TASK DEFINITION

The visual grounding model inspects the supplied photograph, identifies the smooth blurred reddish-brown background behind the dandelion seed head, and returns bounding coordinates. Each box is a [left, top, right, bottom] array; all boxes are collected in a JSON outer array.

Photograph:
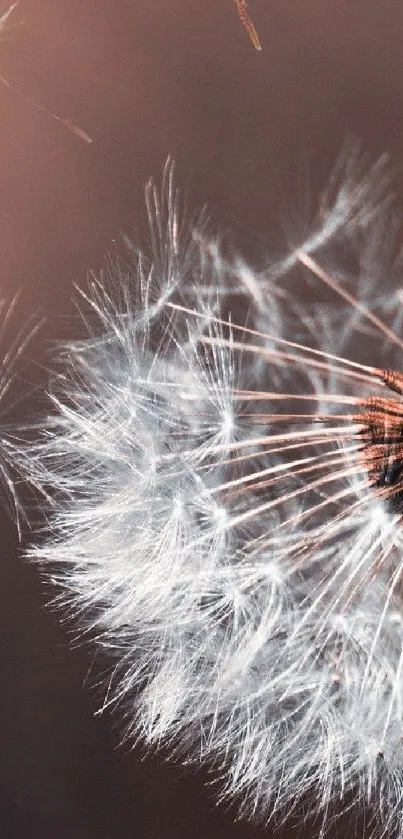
[[0, 0, 403, 839]]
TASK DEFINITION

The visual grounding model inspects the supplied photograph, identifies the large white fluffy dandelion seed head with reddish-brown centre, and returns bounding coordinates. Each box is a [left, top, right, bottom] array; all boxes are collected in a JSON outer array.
[[24, 158, 403, 836]]
